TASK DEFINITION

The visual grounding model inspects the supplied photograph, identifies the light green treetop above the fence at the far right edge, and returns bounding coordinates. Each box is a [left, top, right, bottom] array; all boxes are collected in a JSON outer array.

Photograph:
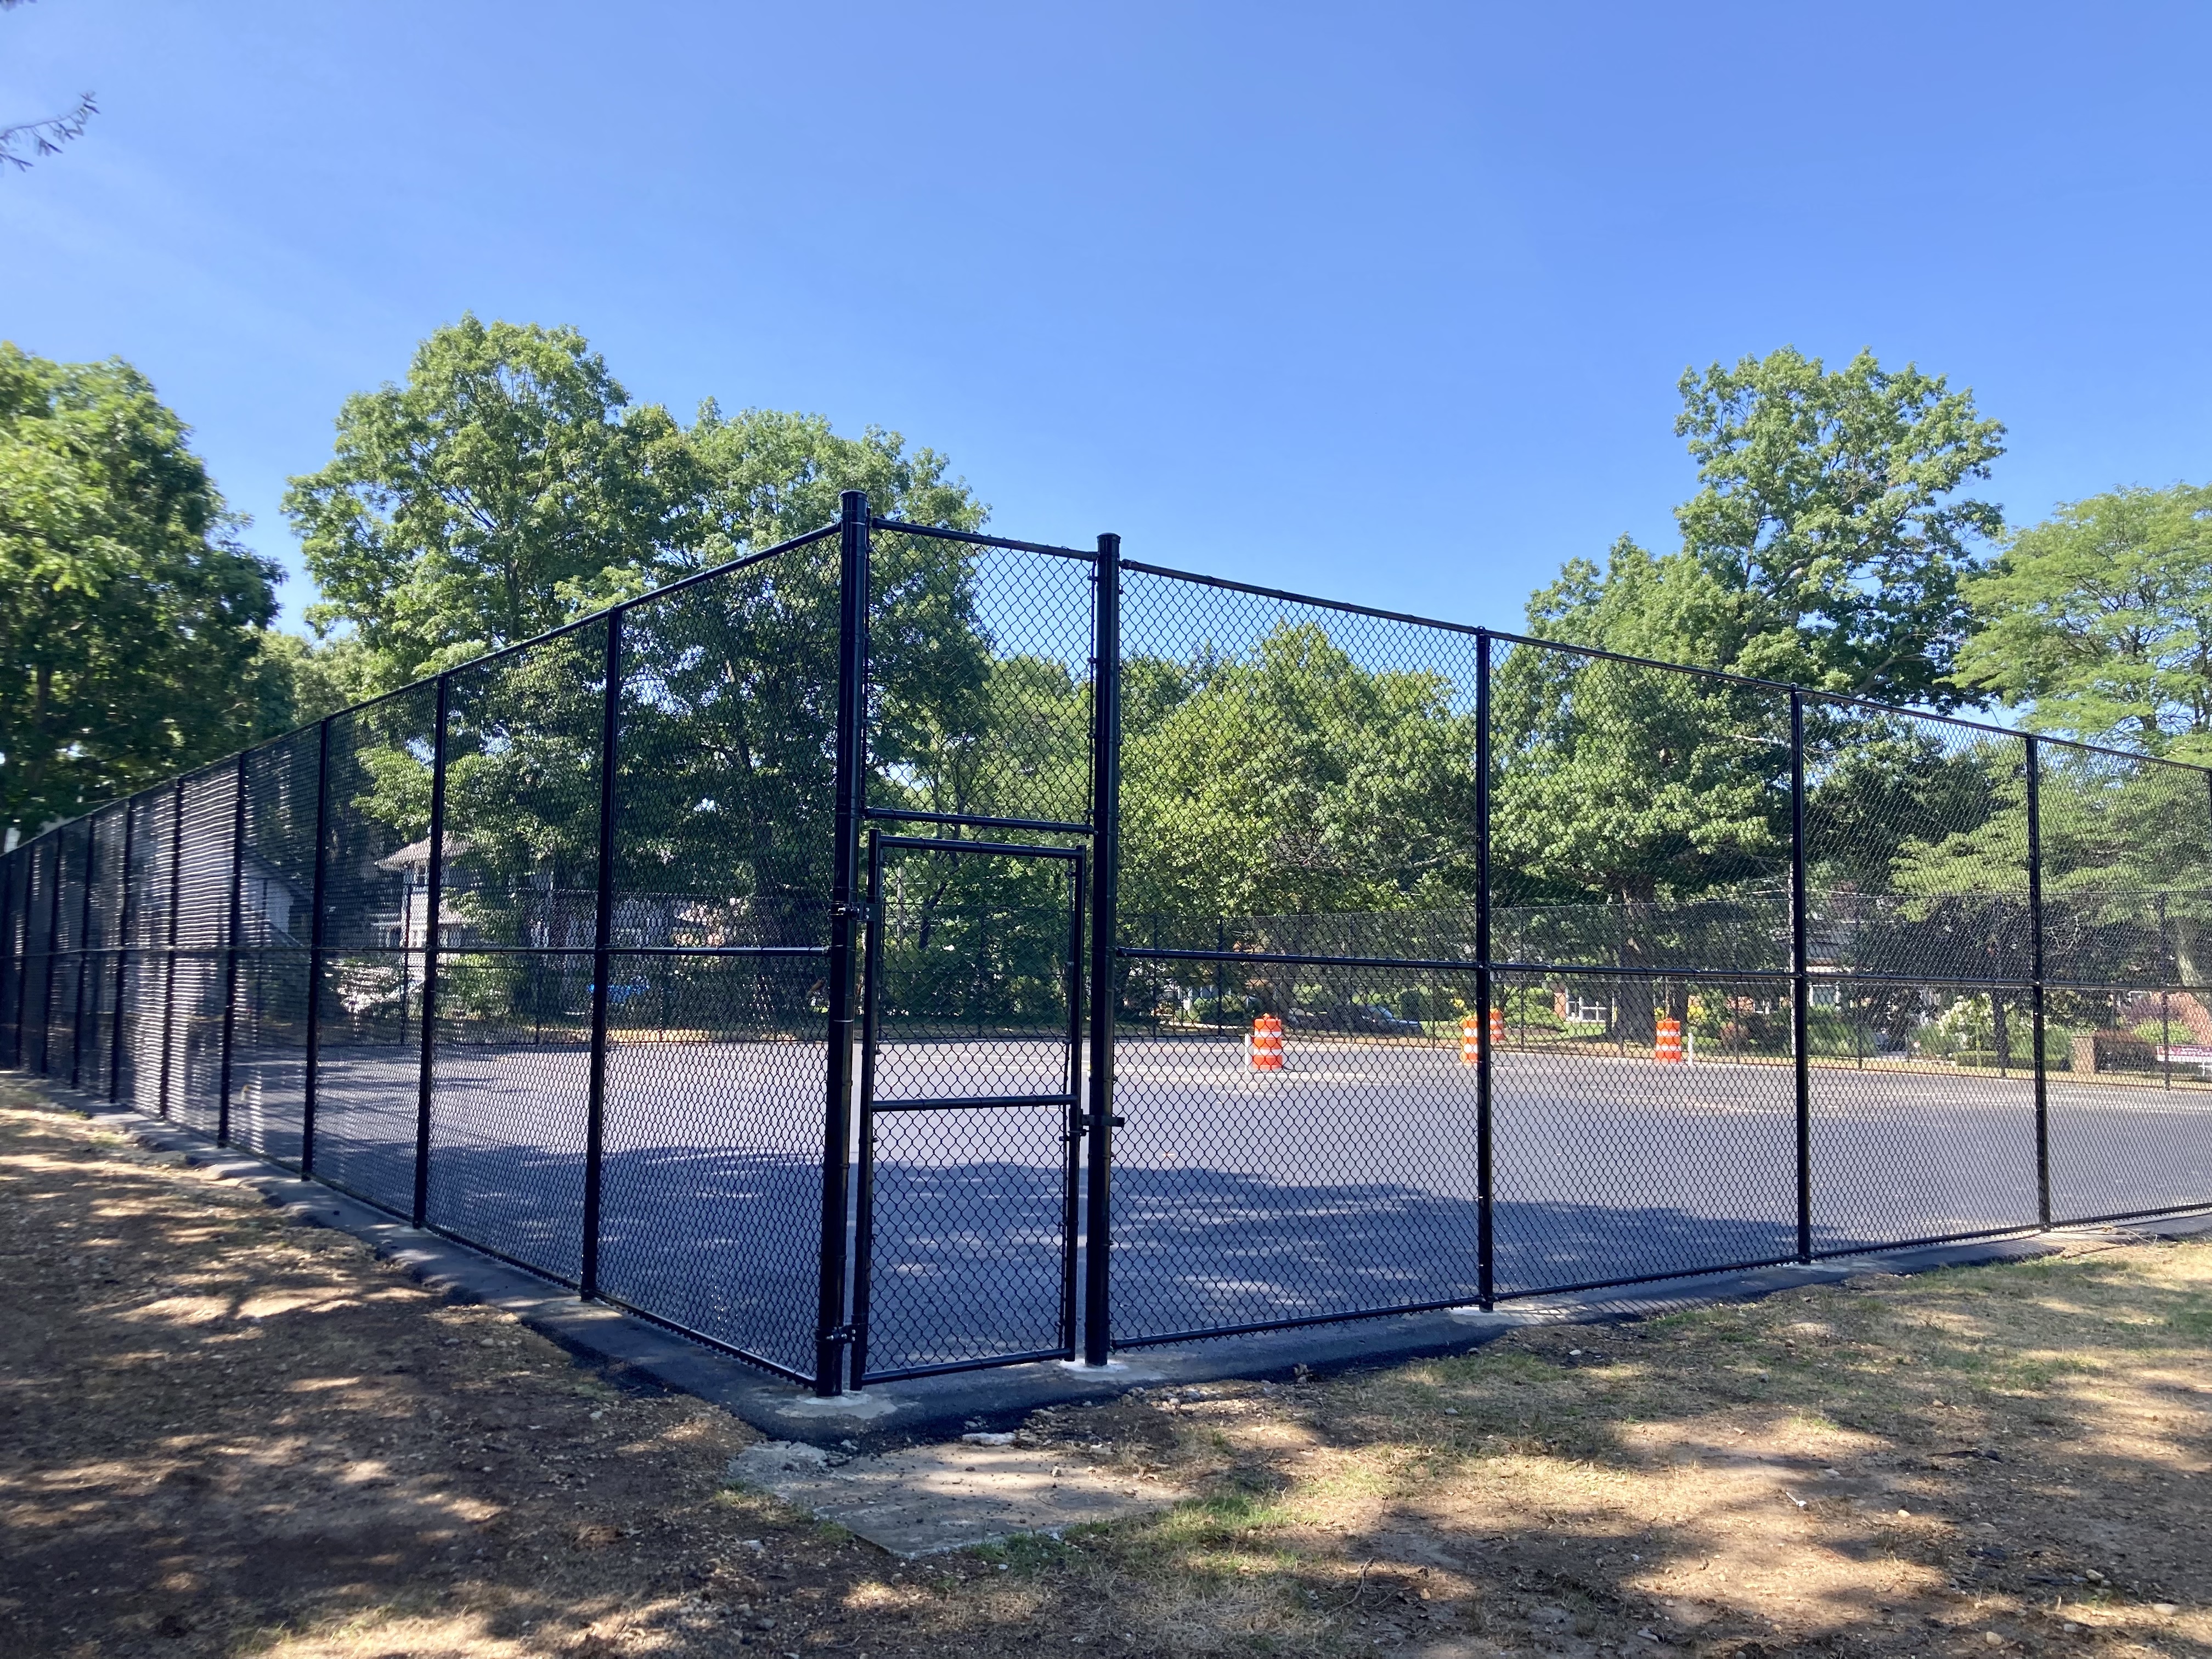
[[1957, 484, 2212, 759]]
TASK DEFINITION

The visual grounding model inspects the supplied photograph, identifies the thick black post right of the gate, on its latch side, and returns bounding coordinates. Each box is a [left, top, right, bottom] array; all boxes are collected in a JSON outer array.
[[1084, 533, 1124, 1365]]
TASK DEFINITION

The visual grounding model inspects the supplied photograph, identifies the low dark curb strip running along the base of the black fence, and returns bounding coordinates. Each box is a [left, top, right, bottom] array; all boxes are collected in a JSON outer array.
[[40, 1084, 2212, 1451]]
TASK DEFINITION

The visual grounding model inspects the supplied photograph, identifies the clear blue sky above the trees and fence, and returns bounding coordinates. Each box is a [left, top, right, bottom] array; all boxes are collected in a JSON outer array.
[[0, 0, 2212, 624]]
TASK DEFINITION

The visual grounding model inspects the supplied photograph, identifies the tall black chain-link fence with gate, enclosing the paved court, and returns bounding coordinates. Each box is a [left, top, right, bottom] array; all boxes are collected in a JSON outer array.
[[0, 495, 2212, 1391]]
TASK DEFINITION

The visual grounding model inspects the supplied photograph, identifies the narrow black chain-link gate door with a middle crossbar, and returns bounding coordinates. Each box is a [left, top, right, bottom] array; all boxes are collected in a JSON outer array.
[[851, 832, 1084, 1383]]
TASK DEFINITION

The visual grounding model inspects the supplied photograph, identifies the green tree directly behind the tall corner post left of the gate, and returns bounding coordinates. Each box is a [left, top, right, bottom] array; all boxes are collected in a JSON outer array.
[[601, 442, 991, 936]]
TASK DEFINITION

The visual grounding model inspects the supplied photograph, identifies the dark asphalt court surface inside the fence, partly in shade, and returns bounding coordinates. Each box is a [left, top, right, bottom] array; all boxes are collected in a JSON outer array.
[[185, 1033, 2212, 1369]]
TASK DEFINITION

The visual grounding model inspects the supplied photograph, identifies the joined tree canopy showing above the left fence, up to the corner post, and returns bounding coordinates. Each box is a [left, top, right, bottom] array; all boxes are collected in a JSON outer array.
[[285, 317, 984, 692]]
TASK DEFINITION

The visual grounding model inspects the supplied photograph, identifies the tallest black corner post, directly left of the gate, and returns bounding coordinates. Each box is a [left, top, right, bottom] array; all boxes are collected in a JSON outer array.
[[814, 489, 870, 1396]]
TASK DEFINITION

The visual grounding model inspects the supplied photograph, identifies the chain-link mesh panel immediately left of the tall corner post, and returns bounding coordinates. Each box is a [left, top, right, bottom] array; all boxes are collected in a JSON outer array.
[[600, 542, 838, 1374]]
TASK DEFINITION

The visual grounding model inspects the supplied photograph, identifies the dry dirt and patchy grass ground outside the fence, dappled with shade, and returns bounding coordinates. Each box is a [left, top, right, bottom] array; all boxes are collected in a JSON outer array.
[[0, 1088, 2212, 1659]]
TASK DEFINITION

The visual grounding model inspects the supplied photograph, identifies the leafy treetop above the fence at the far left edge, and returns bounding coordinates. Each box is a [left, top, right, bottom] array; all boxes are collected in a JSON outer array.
[[0, 345, 290, 832]]
